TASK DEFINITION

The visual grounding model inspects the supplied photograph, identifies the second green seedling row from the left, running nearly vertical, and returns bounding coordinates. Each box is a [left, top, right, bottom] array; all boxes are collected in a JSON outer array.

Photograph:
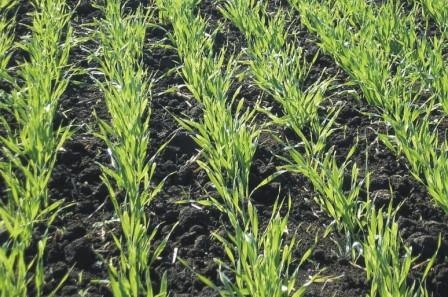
[[92, 0, 168, 297]]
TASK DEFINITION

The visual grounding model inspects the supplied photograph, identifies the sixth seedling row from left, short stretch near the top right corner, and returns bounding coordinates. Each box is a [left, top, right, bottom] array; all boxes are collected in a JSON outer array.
[[302, 0, 448, 114]]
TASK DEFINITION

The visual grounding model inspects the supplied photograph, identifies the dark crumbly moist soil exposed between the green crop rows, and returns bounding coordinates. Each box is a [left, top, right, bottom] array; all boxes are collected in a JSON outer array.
[[1, 1, 448, 297]]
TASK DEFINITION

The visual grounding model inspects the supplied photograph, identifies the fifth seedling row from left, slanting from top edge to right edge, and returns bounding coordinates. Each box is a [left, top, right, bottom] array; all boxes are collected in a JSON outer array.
[[291, 0, 448, 211]]
